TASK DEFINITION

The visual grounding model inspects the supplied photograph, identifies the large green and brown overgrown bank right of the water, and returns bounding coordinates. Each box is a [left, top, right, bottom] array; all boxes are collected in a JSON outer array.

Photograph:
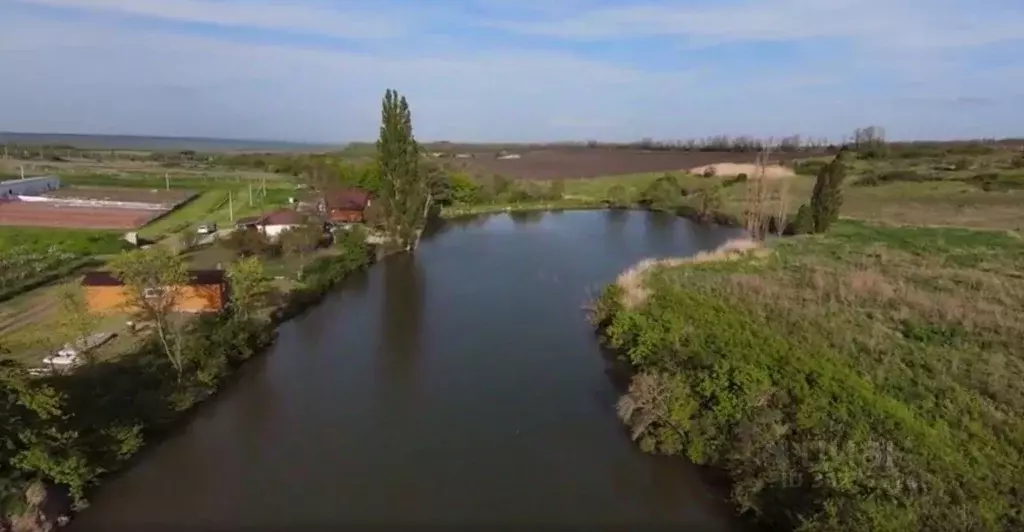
[[595, 222, 1024, 531]]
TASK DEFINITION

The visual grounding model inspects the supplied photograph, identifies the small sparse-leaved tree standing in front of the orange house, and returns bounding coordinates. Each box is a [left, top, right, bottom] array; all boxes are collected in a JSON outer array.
[[110, 246, 188, 382]]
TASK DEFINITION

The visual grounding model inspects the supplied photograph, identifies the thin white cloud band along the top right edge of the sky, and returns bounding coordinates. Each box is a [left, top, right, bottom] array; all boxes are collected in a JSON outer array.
[[489, 0, 1024, 48]]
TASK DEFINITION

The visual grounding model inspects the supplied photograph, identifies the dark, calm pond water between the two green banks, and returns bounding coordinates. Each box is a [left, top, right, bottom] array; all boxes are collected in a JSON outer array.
[[72, 211, 738, 532]]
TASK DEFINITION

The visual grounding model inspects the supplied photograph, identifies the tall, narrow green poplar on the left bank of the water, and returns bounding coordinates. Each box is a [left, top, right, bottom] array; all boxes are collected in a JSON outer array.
[[377, 89, 430, 251]]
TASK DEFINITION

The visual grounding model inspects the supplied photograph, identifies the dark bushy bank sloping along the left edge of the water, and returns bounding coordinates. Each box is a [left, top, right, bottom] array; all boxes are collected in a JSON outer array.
[[0, 231, 372, 525]]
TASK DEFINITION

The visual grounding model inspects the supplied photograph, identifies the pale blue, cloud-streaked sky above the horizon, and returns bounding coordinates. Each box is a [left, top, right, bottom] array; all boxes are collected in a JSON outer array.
[[0, 0, 1024, 142]]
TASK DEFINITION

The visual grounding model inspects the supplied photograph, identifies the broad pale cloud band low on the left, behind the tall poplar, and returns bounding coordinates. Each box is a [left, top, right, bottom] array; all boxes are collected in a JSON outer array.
[[0, 14, 693, 140]]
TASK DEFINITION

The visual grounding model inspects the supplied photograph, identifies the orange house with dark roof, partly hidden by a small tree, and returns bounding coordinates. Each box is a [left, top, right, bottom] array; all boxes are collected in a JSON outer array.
[[82, 270, 228, 314]]
